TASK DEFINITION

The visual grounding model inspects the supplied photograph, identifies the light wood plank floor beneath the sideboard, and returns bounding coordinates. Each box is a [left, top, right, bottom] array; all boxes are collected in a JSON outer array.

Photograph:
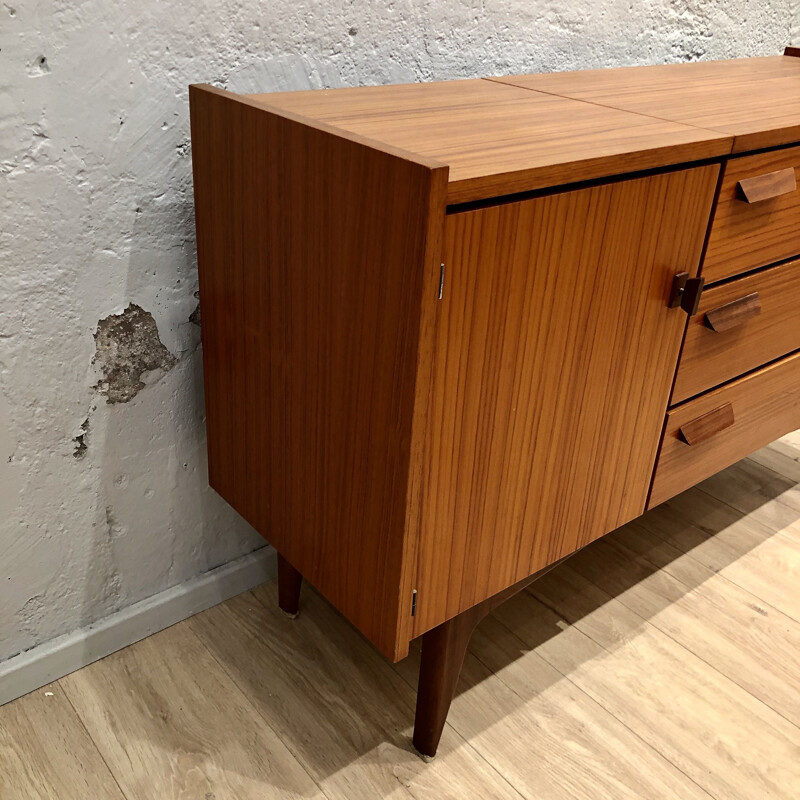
[[0, 432, 800, 800]]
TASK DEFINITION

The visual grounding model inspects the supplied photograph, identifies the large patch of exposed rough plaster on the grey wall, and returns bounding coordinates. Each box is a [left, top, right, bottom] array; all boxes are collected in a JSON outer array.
[[94, 303, 177, 403]]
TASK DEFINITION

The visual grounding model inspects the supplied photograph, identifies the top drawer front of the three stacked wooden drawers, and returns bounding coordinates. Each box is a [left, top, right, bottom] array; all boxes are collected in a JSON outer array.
[[702, 147, 800, 283]]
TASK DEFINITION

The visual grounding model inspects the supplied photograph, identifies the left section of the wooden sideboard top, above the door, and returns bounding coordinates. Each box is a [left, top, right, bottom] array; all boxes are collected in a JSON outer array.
[[250, 80, 733, 203]]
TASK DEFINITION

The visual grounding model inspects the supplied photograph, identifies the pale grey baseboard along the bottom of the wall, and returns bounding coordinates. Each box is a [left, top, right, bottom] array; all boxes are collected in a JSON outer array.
[[0, 546, 276, 705]]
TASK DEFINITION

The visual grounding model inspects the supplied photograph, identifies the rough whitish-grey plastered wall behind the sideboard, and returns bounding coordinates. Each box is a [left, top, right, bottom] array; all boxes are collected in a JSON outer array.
[[0, 0, 796, 660]]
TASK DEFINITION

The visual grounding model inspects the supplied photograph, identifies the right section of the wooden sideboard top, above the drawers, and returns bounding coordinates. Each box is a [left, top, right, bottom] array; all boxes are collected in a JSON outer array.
[[494, 56, 800, 153]]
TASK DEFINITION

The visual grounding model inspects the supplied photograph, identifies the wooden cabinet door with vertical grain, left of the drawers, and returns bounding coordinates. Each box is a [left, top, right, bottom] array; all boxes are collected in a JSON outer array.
[[413, 165, 719, 636]]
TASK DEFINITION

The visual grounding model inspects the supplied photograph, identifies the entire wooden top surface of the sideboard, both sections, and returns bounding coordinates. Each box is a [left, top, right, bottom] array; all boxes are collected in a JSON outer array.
[[248, 56, 800, 203]]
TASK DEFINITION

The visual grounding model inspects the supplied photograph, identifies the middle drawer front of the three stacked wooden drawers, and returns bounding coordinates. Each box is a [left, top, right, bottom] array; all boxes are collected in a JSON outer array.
[[672, 260, 800, 405]]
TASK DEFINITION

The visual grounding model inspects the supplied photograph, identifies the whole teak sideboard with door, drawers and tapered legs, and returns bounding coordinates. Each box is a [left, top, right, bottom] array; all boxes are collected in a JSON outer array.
[[190, 48, 800, 755]]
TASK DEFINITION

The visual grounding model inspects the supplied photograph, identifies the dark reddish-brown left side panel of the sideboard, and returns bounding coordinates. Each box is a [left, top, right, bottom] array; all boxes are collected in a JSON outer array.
[[191, 87, 447, 658]]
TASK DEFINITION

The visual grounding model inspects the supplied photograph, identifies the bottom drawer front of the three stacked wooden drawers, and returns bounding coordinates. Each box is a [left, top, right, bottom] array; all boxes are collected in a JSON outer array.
[[647, 353, 800, 508]]
